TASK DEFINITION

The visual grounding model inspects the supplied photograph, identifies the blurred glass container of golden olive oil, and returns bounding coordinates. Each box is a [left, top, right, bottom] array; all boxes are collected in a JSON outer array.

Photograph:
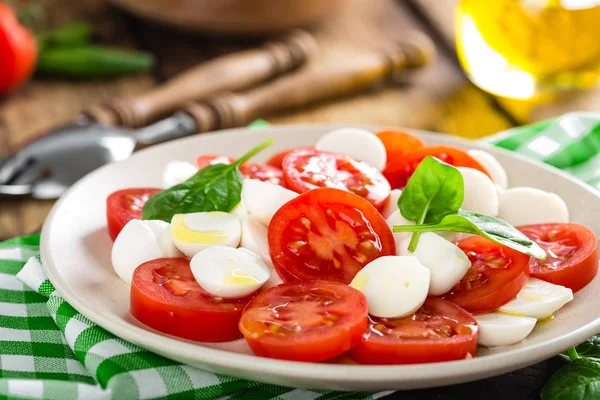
[[456, 0, 600, 99]]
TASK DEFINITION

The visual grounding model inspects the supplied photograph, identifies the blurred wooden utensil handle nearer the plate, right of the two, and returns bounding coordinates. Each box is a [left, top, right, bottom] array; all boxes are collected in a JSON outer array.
[[183, 35, 434, 132]]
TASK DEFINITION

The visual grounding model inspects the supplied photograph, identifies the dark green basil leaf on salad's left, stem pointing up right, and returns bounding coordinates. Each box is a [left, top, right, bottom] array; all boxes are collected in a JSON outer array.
[[142, 139, 273, 222]]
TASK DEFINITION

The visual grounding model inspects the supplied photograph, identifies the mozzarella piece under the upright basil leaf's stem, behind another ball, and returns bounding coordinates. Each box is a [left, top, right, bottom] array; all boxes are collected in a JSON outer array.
[[397, 232, 471, 296]]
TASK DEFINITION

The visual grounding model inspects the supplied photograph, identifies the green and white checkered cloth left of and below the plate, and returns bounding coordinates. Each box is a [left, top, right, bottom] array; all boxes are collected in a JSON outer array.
[[0, 235, 390, 400]]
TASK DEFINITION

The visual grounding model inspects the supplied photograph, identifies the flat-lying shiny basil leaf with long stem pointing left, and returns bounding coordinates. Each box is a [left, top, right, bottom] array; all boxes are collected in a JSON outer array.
[[394, 211, 546, 260]]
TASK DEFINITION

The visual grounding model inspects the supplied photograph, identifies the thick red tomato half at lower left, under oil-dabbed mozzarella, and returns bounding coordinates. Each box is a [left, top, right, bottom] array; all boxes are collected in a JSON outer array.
[[131, 258, 250, 342]]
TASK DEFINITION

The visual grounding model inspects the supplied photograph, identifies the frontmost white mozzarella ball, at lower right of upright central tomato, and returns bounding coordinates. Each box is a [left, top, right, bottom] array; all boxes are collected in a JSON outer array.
[[350, 256, 430, 318]]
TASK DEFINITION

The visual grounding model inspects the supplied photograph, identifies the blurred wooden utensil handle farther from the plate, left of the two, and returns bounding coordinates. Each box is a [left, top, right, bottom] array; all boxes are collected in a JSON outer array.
[[87, 30, 316, 128]]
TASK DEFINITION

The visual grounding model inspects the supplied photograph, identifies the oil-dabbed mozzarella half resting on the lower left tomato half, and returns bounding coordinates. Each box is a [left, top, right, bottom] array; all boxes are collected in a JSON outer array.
[[190, 246, 271, 299]]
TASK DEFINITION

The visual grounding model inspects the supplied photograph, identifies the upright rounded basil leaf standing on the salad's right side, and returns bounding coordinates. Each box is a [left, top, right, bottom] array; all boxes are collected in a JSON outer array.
[[398, 157, 464, 252]]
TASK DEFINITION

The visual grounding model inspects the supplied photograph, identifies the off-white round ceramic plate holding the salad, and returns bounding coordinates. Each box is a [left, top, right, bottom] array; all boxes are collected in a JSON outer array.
[[41, 125, 600, 390]]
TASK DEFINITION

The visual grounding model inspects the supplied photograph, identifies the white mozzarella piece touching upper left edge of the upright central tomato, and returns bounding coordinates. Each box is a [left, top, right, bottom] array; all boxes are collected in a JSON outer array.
[[242, 179, 298, 226]]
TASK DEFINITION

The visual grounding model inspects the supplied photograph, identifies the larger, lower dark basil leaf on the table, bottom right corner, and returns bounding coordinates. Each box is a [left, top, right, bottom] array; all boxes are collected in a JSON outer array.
[[540, 358, 600, 400]]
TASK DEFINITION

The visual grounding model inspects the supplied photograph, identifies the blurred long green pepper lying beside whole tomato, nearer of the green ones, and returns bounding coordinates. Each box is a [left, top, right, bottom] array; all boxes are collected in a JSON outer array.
[[37, 46, 154, 79]]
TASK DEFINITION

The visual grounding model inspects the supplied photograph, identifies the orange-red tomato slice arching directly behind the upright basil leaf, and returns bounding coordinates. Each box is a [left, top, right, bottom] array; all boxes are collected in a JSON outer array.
[[383, 146, 489, 189]]
